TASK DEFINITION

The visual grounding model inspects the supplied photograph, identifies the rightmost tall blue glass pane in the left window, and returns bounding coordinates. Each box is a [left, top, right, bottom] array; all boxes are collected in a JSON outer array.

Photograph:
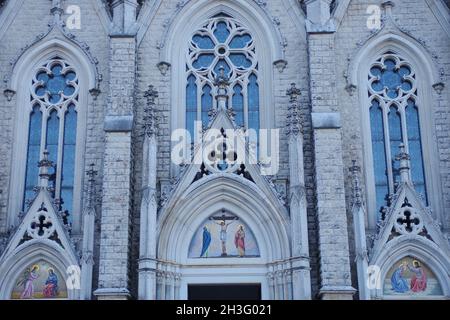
[[61, 105, 77, 218]]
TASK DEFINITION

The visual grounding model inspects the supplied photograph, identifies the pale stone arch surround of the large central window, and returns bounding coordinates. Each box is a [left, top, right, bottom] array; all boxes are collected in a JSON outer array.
[[160, 0, 284, 151]]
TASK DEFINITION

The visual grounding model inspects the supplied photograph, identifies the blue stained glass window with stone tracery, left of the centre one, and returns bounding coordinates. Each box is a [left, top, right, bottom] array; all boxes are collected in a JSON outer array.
[[23, 57, 79, 220]]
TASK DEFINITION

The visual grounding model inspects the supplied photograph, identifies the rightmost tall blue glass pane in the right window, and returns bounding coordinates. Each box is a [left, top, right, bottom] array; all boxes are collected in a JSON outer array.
[[406, 100, 428, 204]]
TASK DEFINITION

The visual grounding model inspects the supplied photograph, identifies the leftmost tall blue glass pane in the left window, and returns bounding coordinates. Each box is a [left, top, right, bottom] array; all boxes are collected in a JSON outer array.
[[22, 105, 42, 210]]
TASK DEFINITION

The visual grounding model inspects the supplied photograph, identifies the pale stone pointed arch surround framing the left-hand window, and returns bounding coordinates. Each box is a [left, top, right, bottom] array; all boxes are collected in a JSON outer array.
[[7, 37, 101, 231]]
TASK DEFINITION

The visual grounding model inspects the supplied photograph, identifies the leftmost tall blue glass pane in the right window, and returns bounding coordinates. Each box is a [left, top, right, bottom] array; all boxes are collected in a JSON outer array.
[[370, 100, 389, 216]]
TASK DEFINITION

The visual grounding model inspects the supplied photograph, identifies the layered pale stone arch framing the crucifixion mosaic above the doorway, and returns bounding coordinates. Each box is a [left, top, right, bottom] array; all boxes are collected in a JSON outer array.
[[157, 173, 290, 264]]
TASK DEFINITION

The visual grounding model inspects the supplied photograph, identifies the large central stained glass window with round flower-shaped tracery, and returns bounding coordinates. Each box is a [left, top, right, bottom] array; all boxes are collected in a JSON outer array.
[[185, 14, 260, 137]]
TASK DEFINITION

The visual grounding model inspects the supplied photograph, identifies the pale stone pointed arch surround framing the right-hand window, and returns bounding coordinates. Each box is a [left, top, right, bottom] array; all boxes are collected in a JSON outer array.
[[347, 31, 442, 229]]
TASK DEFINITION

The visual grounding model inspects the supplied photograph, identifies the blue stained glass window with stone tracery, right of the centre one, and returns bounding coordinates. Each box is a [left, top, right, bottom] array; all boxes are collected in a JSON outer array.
[[368, 51, 428, 218]]
